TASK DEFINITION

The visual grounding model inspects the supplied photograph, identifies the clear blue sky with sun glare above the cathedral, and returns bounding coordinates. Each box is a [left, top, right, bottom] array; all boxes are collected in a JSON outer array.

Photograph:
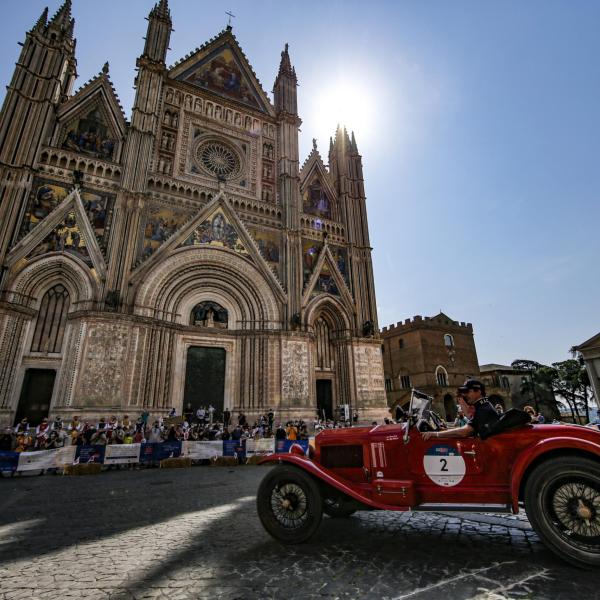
[[0, 0, 600, 363]]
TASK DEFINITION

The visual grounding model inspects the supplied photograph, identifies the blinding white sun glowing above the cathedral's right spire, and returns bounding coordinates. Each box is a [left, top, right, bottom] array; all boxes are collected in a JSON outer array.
[[313, 81, 373, 143]]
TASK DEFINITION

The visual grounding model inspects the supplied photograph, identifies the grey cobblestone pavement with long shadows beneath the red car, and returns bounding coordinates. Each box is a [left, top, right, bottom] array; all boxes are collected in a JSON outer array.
[[0, 467, 600, 600]]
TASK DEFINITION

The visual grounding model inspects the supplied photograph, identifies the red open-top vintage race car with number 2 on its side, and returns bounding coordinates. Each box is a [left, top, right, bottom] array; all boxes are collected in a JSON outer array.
[[257, 391, 600, 568]]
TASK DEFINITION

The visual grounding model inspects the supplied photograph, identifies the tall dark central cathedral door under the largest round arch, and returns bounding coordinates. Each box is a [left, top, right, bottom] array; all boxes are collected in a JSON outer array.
[[183, 346, 225, 418]]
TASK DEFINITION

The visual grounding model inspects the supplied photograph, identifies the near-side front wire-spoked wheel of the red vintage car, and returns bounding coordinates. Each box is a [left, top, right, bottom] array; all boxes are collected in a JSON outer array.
[[256, 465, 323, 544]]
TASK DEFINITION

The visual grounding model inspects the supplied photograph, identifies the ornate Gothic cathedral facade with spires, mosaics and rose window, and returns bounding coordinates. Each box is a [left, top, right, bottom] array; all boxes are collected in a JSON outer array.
[[0, 0, 386, 424]]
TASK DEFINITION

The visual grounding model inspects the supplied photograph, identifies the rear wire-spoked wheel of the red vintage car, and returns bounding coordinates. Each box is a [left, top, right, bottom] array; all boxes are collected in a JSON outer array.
[[525, 456, 600, 568]]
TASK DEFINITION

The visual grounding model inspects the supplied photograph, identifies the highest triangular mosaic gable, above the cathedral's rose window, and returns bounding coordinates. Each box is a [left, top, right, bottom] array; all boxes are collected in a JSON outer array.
[[171, 33, 272, 113]]
